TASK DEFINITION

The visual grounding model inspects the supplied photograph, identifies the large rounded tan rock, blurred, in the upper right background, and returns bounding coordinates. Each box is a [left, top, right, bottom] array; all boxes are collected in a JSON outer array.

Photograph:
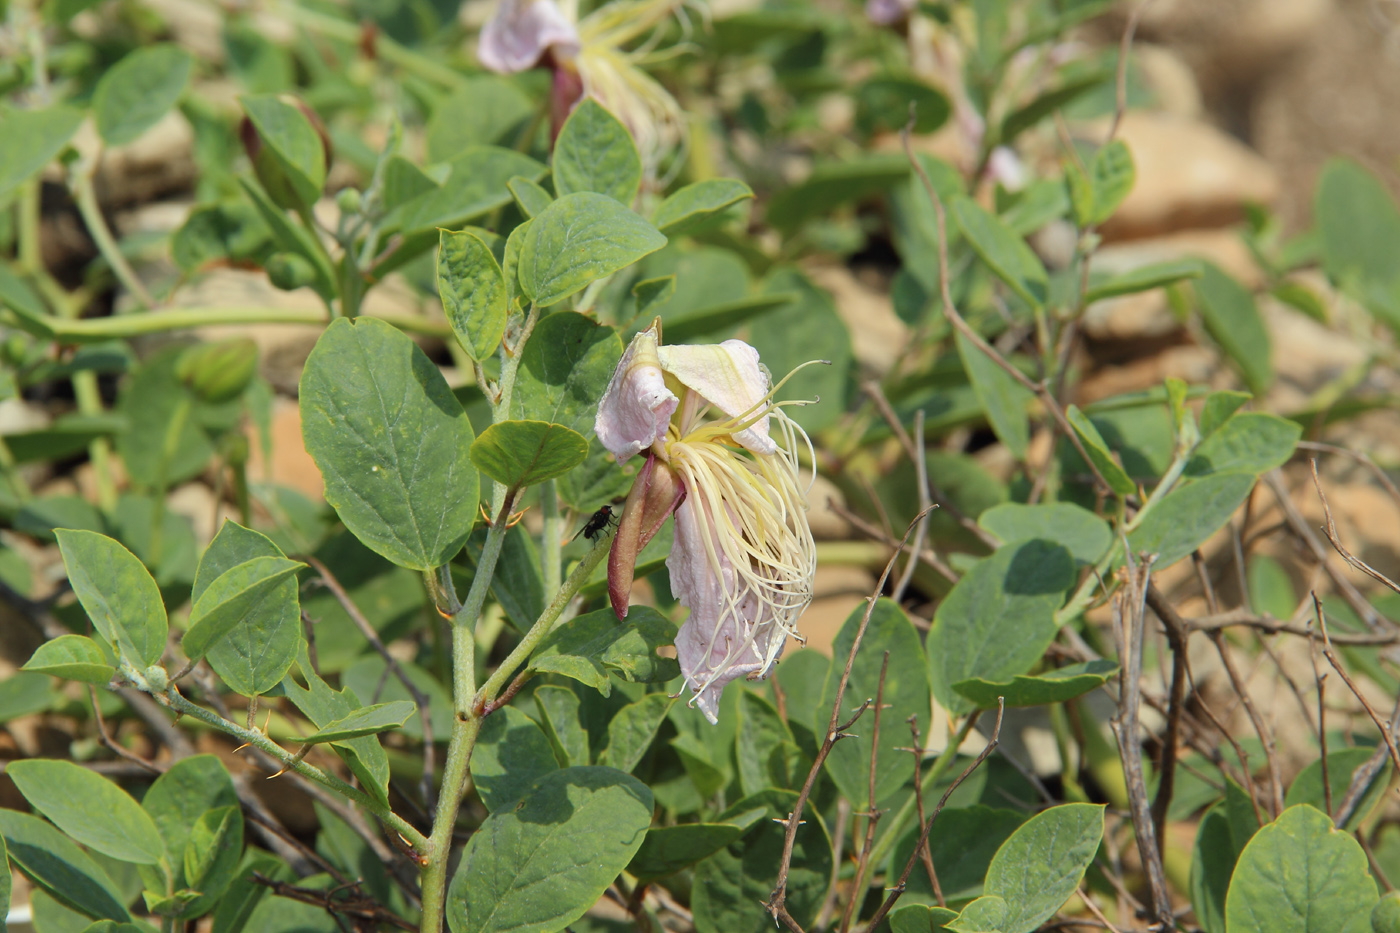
[[1098, 111, 1278, 240]]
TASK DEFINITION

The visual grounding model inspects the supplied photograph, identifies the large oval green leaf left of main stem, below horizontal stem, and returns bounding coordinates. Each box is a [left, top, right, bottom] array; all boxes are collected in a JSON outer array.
[[301, 318, 479, 572]]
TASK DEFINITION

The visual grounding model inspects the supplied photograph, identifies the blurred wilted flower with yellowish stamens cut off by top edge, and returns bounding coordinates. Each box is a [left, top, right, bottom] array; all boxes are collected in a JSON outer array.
[[477, 0, 686, 171]]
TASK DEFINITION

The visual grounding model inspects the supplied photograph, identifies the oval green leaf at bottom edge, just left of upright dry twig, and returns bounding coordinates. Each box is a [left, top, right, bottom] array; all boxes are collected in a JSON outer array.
[[986, 804, 1103, 933]]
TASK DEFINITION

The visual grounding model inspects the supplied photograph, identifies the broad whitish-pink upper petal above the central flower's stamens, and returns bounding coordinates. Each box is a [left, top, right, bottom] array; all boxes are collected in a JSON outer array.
[[657, 340, 777, 454]]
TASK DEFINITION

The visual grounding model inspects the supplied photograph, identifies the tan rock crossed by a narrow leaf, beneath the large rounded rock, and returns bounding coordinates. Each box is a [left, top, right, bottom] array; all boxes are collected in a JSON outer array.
[[1082, 230, 1263, 340]]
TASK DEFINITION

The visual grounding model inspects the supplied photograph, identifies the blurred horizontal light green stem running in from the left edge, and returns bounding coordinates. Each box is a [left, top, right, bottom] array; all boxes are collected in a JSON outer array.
[[7, 307, 452, 343]]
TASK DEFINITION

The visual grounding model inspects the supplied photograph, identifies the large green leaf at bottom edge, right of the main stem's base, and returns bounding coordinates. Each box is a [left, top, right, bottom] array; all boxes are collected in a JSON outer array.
[[447, 768, 652, 933]]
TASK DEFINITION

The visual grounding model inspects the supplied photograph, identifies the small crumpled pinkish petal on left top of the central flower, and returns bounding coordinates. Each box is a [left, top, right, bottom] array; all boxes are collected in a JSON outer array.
[[594, 328, 680, 462]]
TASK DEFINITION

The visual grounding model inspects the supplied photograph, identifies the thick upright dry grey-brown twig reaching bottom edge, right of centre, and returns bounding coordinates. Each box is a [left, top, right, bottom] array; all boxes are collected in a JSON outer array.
[[1109, 553, 1176, 930]]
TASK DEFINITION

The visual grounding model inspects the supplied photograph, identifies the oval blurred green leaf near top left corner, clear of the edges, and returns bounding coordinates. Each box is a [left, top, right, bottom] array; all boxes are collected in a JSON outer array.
[[92, 42, 190, 146]]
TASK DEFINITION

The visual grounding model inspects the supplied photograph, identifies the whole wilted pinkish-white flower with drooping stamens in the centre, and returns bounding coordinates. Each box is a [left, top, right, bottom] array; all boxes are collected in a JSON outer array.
[[595, 321, 816, 721]]
